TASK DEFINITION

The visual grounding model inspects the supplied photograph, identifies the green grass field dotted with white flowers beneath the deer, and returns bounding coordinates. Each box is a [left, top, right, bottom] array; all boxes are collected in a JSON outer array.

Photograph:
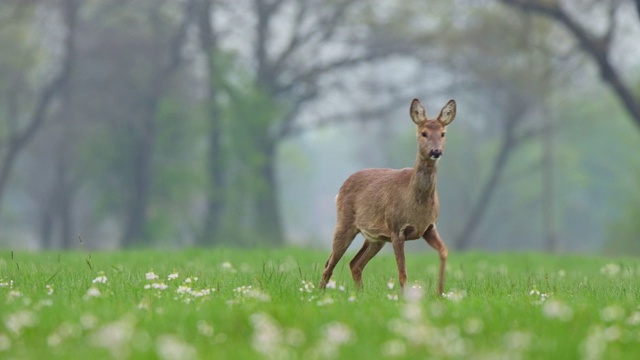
[[0, 248, 640, 359]]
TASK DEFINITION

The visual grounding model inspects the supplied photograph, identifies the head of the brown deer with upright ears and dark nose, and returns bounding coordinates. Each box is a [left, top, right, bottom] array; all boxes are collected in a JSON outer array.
[[409, 99, 456, 163]]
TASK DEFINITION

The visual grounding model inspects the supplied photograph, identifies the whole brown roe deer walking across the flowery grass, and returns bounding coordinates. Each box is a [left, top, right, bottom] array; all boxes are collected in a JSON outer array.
[[319, 99, 456, 294]]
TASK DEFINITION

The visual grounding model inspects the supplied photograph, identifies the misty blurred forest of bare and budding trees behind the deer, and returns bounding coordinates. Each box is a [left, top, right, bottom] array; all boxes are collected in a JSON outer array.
[[0, 0, 640, 254]]
